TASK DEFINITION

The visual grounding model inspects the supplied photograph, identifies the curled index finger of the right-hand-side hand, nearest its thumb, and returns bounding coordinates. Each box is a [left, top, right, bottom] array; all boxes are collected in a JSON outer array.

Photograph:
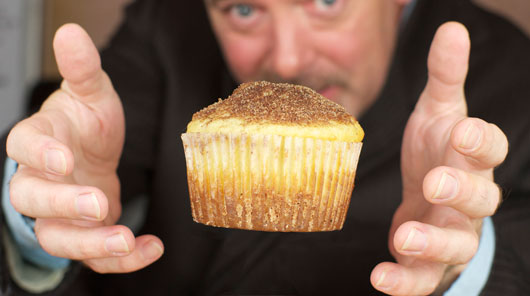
[[451, 118, 508, 169]]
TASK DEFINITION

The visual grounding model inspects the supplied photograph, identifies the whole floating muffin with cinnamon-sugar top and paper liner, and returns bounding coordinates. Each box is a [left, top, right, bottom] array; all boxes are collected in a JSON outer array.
[[182, 81, 364, 232]]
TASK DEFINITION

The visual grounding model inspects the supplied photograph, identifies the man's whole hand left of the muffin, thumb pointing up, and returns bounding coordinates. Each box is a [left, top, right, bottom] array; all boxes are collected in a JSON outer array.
[[7, 24, 163, 273]]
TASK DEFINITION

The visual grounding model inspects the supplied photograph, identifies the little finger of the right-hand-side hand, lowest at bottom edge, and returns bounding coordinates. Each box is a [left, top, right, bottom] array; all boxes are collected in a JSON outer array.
[[370, 262, 445, 296]]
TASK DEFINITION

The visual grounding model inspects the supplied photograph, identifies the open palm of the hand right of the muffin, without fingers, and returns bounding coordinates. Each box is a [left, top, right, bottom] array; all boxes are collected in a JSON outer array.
[[389, 93, 470, 261]]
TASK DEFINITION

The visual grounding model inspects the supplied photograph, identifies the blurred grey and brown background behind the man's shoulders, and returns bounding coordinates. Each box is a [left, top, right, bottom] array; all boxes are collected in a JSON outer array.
[[0, 0, 530, 134]]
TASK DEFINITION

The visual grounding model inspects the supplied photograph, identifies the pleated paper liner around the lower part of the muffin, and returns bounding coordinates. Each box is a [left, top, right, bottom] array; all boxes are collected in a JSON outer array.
[[182, 133, 362, 232]]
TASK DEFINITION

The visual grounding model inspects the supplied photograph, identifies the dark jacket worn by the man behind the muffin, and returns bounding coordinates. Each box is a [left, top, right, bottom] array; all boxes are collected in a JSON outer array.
[[2, 0, 530, 295]]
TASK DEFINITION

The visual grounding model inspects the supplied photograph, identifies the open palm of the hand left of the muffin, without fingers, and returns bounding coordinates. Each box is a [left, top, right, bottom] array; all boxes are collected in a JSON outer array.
[[41, 84, 125, 225]]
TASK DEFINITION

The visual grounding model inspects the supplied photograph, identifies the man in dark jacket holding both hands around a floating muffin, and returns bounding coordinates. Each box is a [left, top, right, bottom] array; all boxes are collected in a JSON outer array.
[[0, 0, 530, 295]]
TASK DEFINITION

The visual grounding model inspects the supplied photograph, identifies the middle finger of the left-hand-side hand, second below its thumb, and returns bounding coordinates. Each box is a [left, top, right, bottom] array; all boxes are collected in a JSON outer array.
[[9, 167, 108, 221]]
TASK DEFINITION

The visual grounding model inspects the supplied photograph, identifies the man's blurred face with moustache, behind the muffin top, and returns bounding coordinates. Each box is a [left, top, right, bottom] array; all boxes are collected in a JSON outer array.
[[206, 0, 404, 116]]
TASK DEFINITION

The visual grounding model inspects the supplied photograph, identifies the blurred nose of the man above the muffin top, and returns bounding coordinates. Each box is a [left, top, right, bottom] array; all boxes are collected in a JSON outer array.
[[271, 16, 309, 81]]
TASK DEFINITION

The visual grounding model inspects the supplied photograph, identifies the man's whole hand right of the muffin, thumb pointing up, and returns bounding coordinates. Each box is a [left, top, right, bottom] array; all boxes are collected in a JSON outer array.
[[371, 23, 508, 295]]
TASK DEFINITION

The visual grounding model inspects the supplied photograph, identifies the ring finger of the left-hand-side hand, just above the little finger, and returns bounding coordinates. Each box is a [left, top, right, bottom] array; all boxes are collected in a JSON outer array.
[[35, 219, 135, 260]]
